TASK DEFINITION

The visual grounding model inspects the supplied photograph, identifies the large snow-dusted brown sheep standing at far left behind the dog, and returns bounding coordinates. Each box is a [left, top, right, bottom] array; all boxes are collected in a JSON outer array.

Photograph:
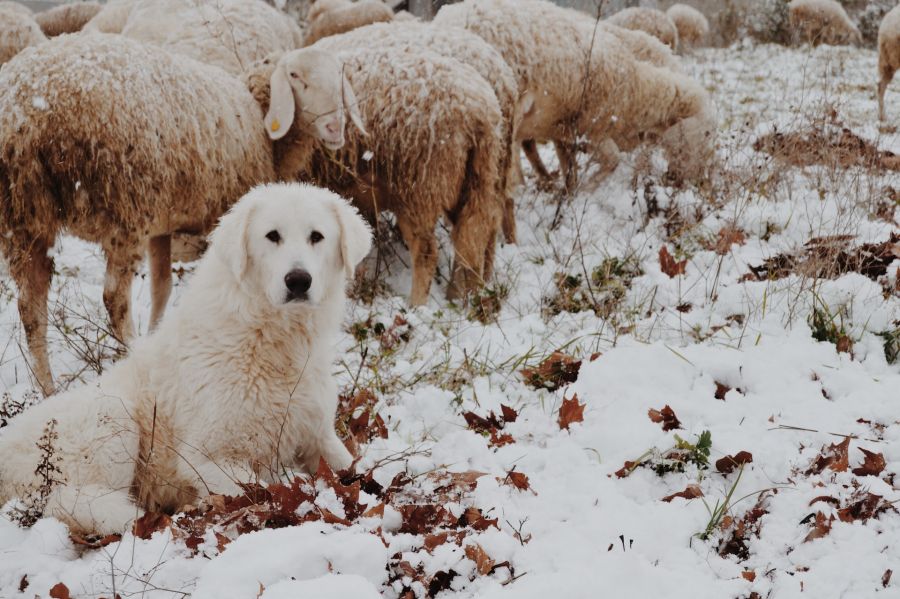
[[0, 33, 360, 393]]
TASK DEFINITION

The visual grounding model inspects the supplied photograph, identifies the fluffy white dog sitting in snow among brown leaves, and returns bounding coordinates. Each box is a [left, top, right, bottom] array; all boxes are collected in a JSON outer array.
[[0, 184, 372, 534]]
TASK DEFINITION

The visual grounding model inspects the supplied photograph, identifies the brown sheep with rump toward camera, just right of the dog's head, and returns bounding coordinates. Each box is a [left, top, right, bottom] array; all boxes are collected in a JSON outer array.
[[251, 40, 504, 306]]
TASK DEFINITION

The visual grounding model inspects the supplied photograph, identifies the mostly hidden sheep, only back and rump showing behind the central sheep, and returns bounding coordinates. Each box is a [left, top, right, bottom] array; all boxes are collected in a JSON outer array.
[[312, 21, 527, 243]]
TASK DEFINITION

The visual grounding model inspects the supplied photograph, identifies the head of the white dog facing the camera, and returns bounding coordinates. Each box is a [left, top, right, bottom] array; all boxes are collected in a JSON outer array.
[[210, 183, 372, 309]]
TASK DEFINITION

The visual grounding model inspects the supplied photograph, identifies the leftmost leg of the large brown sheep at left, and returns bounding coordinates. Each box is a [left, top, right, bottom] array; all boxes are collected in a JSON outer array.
[[7, 240, 53, 395]]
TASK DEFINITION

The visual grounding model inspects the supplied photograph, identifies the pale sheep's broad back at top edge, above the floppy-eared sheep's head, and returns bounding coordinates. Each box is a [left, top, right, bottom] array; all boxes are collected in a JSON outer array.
[[122, 0, 302, 75]]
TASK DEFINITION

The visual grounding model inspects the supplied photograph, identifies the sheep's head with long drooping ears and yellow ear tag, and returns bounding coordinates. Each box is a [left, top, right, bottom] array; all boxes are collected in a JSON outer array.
[[265, 48, 366, 150]]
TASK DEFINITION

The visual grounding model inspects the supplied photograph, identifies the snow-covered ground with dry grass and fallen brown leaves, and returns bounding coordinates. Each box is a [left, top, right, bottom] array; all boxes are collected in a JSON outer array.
[[0, 45, 900, 599]]
